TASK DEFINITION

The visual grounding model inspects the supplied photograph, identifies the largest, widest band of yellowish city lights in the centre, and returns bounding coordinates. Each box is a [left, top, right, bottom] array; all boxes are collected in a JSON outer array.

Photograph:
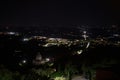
[[23, 36, 90, 47]]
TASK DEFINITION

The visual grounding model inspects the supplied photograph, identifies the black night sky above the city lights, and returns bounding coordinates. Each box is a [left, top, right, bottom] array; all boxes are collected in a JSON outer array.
[[0, 0, 120, 25]]
